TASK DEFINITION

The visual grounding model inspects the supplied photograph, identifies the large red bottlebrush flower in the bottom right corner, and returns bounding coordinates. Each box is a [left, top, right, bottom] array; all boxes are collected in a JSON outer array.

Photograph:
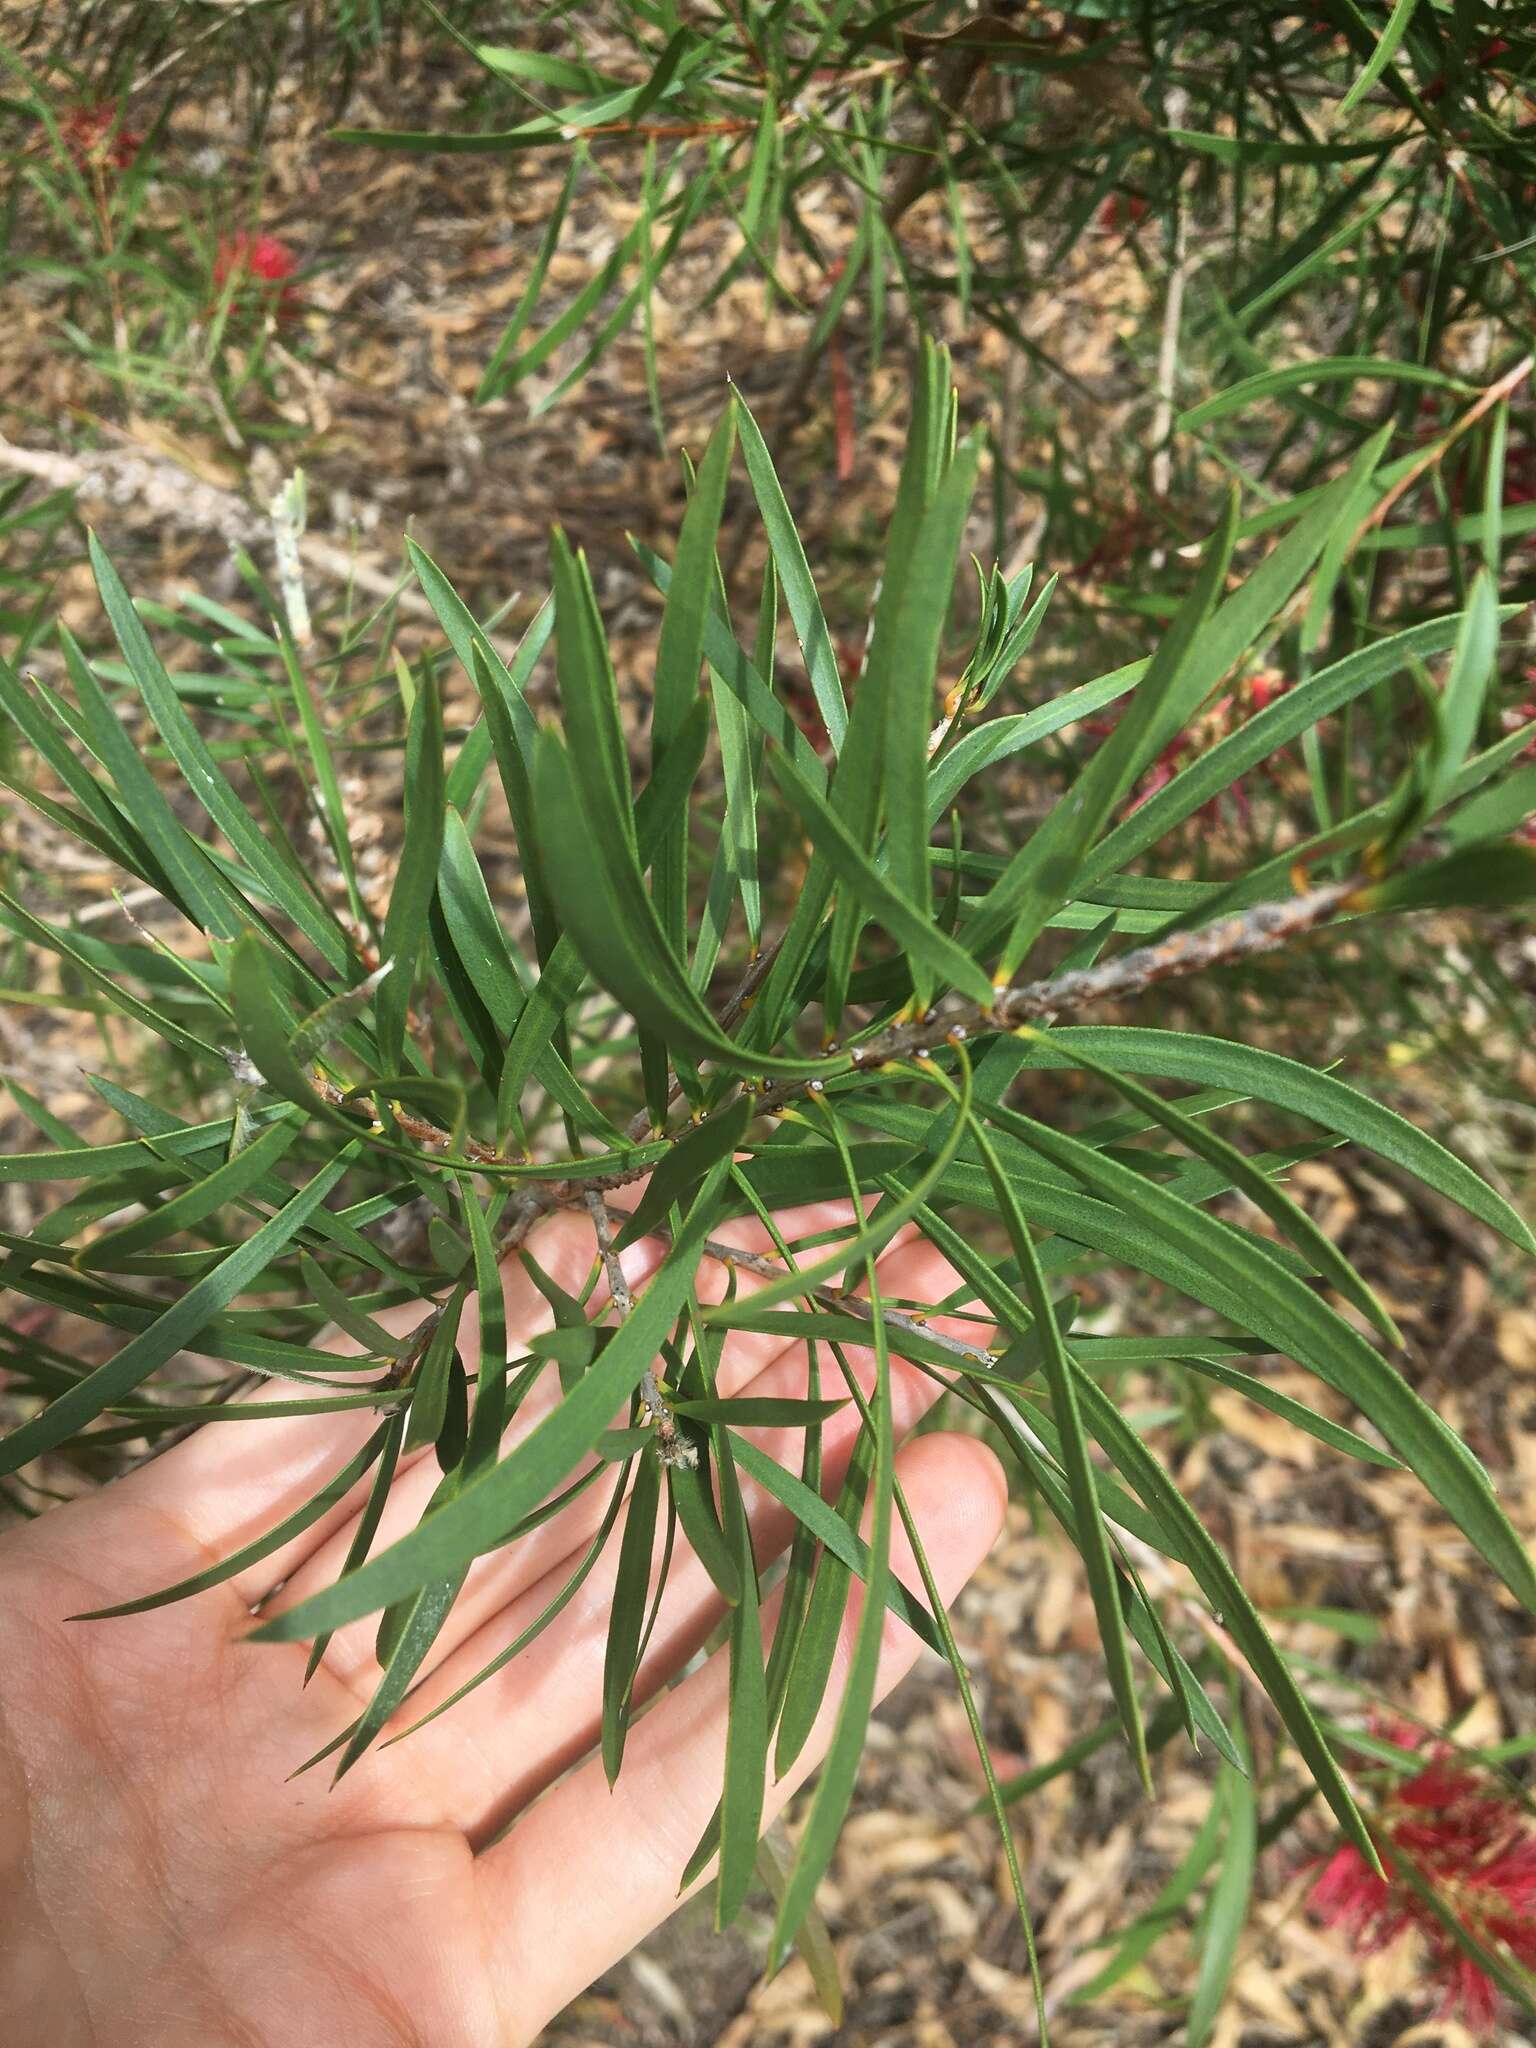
[[1311, 1726, 1536, 2032]]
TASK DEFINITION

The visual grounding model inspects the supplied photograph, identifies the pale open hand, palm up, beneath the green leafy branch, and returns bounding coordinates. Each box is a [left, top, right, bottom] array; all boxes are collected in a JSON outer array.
[[0, 1206, 1006, 2048]]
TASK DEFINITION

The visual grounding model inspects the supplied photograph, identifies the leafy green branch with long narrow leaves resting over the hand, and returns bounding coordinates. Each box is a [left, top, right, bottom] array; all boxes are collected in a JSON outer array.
[[0, 350, 1536, 2015]]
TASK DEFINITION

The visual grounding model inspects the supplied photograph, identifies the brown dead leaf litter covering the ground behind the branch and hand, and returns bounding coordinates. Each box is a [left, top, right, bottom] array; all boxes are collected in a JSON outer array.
[[0, 19, 1536, 2048]]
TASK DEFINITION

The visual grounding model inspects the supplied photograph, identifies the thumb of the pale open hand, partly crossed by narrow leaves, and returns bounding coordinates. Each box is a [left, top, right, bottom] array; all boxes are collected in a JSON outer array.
[[477, 1436, 1008, 2038]]
